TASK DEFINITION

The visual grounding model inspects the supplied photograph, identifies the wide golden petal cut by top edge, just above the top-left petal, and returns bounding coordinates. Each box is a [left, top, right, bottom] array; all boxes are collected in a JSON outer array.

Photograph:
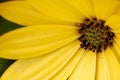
[[27, 0, 85, 23]]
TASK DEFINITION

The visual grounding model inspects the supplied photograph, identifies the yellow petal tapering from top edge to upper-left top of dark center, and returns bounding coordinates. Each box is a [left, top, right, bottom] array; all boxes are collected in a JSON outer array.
[[65, 0, 95, 17]]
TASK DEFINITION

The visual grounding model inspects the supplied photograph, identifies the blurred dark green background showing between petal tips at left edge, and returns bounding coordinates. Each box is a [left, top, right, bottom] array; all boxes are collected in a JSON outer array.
[[0, 0, 22, 76]]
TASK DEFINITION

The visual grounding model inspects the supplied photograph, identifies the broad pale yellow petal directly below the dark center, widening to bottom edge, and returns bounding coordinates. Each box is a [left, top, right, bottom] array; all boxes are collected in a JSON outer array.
[[69, 51, 96, 80]]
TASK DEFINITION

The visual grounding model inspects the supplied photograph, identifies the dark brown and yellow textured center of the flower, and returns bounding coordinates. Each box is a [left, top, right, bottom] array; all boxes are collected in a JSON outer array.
[[77, 18, 115, 53]]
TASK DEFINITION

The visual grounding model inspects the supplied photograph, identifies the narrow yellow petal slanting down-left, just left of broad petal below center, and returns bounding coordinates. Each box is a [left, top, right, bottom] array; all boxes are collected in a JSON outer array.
[[51, 49, 85, 80]]
